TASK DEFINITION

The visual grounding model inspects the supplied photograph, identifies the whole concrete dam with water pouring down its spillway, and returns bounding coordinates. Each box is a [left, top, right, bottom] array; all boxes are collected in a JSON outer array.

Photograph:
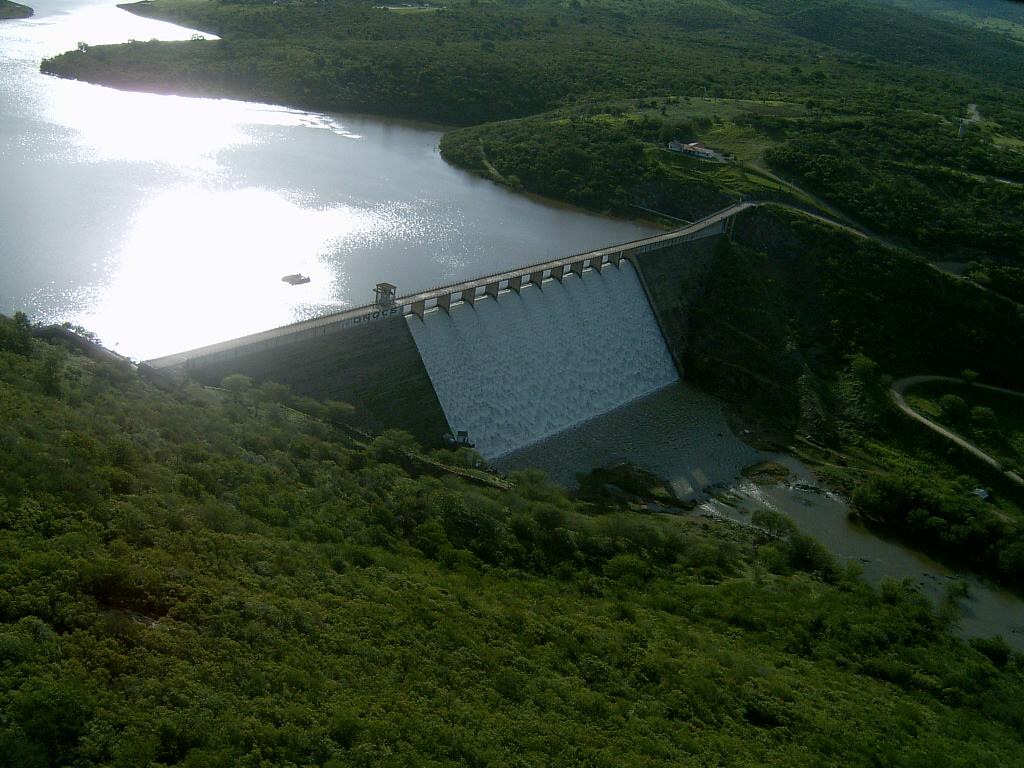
[[143, 203, 758, 460]]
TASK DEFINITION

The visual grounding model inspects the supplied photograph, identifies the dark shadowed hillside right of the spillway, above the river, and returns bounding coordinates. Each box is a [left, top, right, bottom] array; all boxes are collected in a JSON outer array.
[[641, 207, 1024, 590]]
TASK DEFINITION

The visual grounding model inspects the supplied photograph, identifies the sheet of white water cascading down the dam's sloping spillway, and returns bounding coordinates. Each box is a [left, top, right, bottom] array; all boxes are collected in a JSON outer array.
[[408, 261, 679, 459]]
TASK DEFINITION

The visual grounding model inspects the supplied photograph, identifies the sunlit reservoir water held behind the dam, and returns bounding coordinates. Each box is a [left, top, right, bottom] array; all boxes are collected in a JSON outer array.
[[0, 0, 654, 358]]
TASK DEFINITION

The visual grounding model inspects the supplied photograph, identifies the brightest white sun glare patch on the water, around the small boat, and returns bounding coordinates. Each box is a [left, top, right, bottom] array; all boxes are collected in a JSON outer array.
[[73, 187, 380, 352]]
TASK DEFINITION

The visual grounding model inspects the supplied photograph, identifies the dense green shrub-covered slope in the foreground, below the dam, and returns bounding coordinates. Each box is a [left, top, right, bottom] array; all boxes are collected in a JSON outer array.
[[6, 318, 1024, 768]]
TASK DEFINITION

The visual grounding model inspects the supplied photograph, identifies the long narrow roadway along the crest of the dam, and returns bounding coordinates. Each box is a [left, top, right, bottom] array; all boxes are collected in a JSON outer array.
[[146, 202, 759, 374]]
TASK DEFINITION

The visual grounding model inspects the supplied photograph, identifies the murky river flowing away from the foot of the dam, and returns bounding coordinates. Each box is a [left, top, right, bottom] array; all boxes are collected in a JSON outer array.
[[498, 382, 1024, 652]]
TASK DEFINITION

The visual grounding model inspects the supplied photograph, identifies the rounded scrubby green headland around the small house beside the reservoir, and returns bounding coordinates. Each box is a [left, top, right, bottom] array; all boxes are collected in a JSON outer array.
[[440, 96, 813, 220]]
